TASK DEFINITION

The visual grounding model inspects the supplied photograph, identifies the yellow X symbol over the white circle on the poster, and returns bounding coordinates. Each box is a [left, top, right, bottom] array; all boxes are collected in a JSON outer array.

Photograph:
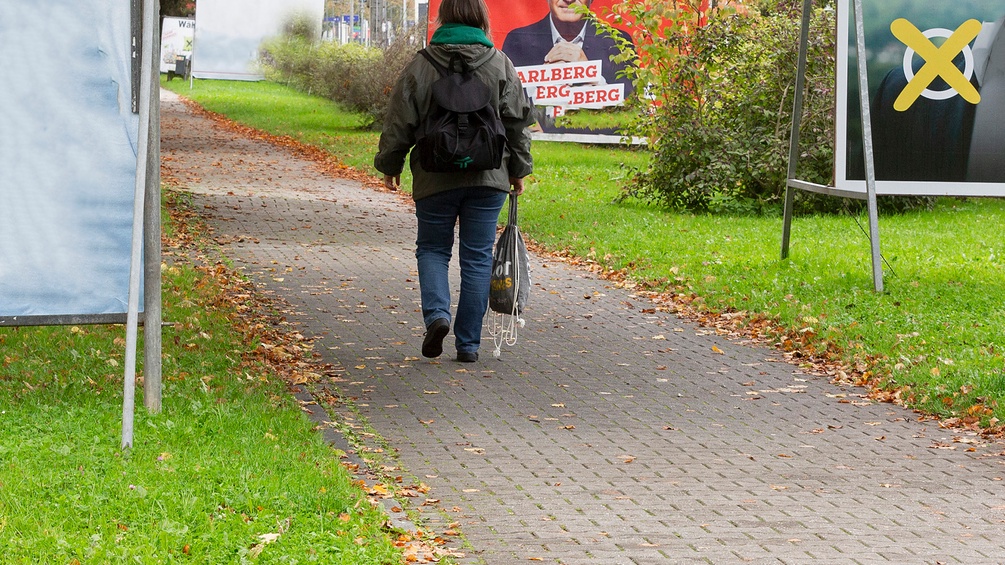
[[889, 18, 982, 112]]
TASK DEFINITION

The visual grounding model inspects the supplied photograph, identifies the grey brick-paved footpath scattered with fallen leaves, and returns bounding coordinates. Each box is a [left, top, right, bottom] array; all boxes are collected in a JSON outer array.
[[162, 89, 1005, 565]]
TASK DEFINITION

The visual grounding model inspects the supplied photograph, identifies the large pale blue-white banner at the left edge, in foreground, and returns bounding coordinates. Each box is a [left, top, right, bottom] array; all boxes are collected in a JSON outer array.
[[0, 0, 139, 317]]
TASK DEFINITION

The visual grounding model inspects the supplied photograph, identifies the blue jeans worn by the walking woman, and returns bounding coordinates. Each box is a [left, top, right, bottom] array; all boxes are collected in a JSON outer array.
[[415, 187, 507, 352]]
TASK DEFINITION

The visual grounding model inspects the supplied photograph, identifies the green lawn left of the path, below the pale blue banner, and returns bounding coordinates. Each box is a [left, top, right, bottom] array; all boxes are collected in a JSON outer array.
[[0, 192, 402, 565]]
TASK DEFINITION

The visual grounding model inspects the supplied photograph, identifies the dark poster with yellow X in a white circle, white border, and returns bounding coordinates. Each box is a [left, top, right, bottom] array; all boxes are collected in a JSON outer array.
[[835, 0, 1005, 196]]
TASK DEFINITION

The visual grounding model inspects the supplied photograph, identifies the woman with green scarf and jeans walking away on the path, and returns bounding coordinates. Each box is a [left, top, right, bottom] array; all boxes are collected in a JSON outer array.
[[374, 0, 533, 363]]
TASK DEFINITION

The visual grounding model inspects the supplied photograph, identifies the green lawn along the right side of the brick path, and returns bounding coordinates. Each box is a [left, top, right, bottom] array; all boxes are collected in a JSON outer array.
[[162, 80, 1005, 426]]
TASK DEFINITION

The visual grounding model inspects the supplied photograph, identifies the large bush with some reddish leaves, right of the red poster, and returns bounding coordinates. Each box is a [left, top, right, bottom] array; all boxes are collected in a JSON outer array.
[[603, 0, 839, 213]]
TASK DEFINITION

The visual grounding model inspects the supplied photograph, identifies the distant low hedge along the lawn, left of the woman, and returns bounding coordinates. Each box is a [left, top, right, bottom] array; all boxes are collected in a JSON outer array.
[[259, 31, 421, 126]]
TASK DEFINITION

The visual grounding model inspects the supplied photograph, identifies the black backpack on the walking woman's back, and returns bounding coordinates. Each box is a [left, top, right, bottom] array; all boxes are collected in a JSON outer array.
[[415, 49, 506, 173]]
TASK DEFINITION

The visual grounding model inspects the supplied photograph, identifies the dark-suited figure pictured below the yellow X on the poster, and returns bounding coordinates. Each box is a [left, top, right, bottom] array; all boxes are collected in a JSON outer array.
[[871, 14, 1005, 182]]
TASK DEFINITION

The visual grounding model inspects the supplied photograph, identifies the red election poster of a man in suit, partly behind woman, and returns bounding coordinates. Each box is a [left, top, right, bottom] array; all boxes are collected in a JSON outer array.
[[429, 0, 632, 142]]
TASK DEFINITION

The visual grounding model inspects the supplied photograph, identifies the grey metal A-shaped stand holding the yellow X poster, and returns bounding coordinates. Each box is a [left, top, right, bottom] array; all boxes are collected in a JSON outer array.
[[782, 0, 883, 293]]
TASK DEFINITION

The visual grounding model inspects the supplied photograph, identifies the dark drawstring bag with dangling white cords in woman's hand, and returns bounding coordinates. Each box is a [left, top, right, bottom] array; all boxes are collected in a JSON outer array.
[[487, 192, 531, 357]]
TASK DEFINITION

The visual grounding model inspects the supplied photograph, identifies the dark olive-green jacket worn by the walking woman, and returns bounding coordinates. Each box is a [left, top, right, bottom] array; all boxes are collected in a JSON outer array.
[[374, 44, 534, 200]]
